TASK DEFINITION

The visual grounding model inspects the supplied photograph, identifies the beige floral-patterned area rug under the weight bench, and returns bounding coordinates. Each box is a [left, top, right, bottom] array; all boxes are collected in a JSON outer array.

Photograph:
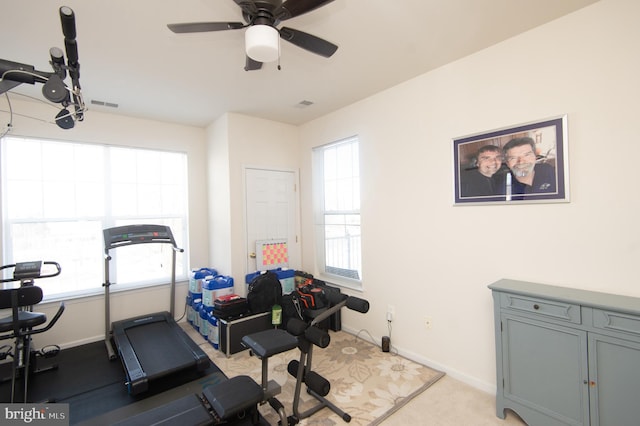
[[185, 325, 444, 425]]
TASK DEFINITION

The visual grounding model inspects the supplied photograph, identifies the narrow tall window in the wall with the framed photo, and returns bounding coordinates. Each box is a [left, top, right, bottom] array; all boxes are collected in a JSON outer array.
[[313, 137, 362, 289]]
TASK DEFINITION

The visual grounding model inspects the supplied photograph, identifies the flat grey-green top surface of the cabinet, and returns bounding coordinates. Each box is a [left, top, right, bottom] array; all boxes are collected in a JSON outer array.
[[488, 279, 640, 314]]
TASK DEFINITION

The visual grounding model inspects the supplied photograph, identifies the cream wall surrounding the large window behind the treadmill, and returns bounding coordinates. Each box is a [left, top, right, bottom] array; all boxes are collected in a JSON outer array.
[[0, 97, 209, 347]]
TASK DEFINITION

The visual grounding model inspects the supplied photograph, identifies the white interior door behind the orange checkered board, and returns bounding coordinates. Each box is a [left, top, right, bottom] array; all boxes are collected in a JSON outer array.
[[245, 168, 301, 273]]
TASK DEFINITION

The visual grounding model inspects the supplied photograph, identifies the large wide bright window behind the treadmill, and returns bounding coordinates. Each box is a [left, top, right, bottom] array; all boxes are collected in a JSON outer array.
[[2, 137, 188, 299]]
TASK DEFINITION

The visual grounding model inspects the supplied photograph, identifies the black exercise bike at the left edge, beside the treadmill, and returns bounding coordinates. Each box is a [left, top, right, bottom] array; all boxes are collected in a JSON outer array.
[[0, 261, 64, 403]]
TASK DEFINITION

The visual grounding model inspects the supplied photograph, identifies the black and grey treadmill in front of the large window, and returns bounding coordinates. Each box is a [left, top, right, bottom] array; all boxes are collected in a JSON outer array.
[[103, 225, 210, 395]]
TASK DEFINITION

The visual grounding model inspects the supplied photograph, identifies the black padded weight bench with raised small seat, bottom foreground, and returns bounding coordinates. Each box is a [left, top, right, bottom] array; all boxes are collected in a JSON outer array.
[[116, 329, 298, 426]]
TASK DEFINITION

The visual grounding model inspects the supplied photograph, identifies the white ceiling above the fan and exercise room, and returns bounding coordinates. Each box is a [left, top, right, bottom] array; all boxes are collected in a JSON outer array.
[[0, 0, 596, 127]]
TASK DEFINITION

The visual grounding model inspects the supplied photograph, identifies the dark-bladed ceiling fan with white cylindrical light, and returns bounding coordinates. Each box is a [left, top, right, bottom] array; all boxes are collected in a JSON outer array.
[[167, 0, 338, 71]]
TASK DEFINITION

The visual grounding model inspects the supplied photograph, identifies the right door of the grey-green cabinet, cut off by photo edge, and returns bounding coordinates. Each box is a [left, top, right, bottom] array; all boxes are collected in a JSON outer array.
[[589, 333, 640, 426]]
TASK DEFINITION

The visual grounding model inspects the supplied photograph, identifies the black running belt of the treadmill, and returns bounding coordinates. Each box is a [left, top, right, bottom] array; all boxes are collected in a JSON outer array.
[[125, 321, 196, 380]]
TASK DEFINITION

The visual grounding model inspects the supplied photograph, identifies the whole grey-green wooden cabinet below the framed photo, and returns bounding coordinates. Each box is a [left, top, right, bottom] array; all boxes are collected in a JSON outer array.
[[489, 280, 640, 426]]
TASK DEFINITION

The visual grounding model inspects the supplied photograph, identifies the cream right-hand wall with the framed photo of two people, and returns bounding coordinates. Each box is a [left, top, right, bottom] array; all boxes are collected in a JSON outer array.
[[300, 0, 640, 391]]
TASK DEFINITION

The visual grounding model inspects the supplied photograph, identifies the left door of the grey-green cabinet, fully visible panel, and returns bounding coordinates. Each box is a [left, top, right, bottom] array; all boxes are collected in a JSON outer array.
[[502, 314, 589, 425]]
